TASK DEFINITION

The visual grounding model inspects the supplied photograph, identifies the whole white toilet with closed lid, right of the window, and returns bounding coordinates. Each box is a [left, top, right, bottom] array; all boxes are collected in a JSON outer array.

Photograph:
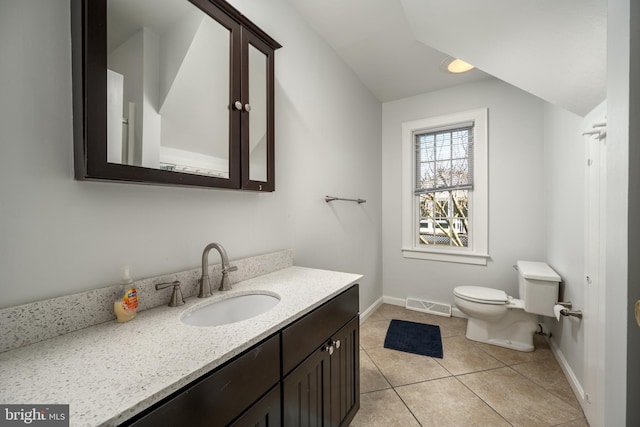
[[453, 261, 561, 351]]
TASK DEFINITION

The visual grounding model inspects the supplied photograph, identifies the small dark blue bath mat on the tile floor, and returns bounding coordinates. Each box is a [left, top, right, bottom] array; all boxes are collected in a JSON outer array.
[[384, 319, 442, 359]]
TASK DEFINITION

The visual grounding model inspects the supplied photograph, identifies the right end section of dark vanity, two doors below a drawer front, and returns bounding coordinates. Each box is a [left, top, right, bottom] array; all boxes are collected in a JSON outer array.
[[282, 286, 360, 427]]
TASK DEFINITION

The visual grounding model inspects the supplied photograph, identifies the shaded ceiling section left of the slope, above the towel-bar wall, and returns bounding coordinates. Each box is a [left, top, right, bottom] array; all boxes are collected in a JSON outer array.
[[287, 0, 490, 102]]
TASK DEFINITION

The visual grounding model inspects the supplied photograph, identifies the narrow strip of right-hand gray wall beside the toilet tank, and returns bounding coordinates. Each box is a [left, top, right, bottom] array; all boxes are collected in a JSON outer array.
[[540, 103, 585, 383]]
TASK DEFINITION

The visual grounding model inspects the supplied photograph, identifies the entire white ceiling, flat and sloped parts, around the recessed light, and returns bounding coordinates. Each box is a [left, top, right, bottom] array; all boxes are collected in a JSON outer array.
[[287, 0, 607, 115]]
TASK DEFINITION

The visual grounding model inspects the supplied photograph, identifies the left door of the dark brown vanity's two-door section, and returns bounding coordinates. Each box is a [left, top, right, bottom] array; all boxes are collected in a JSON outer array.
[[282, 347, 331, 427]]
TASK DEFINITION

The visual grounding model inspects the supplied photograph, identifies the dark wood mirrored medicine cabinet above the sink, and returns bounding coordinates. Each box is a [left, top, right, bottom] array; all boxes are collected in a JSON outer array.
[[71, 0, 281, 191]]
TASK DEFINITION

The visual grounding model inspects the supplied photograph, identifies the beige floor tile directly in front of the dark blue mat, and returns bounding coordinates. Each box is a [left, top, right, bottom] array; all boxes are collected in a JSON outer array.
[[367, 348, 451, 387]]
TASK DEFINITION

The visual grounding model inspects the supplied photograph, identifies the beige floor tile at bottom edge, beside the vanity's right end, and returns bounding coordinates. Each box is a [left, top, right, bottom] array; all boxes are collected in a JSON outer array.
[[350, 389, 420, 427]]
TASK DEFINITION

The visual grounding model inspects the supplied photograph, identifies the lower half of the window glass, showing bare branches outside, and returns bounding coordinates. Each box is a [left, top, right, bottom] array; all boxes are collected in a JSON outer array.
[[418, 190, 469, 247]]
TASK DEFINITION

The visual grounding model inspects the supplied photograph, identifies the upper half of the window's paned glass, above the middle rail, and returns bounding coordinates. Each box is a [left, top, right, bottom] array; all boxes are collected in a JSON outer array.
[[414, 122, 473, 194]]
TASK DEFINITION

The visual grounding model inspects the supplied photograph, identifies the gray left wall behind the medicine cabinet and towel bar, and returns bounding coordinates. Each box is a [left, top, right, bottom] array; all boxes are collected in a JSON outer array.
[[0, 0, 382, 307]]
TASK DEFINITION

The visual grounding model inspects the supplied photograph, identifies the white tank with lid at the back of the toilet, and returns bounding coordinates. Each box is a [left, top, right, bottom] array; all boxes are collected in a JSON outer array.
[[517, 261, 561, 317]]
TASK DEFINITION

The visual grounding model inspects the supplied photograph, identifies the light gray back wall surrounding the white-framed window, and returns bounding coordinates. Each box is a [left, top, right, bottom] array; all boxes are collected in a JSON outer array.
[[382, 79, 547, 304]]
